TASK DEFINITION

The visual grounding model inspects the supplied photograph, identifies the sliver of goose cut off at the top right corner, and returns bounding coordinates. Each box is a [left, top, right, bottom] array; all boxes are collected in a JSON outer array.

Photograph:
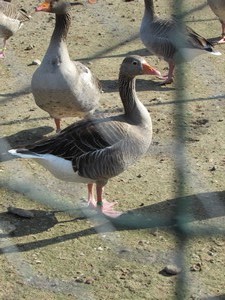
[[207, 0, 225, 44]]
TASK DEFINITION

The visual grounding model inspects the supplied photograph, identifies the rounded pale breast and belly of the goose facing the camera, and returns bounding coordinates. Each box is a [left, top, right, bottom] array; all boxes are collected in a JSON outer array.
[[31, 61, 100, 118]]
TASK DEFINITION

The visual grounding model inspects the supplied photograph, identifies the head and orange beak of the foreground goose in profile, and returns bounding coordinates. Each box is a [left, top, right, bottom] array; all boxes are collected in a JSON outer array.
[[120, 55, 161, 78]]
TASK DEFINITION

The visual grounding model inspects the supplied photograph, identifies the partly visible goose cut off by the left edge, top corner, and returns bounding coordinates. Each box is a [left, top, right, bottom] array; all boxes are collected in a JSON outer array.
[[0, 0, 30, 58]]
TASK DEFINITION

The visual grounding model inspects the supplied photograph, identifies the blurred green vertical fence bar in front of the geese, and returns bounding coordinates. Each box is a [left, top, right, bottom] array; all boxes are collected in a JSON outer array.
[[173, 0, 188, 300]]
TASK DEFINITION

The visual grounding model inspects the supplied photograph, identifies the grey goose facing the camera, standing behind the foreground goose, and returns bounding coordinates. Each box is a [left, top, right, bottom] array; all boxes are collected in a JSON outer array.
[[31, 0, 101, 132]]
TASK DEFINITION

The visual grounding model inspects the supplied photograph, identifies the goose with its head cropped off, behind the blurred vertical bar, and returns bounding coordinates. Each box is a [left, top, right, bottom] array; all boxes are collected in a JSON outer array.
[[140, 0, 221, 84]]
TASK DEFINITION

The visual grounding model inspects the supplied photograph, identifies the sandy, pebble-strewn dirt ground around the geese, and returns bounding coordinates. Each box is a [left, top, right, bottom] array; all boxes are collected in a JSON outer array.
[[0, 0, 225, 300]]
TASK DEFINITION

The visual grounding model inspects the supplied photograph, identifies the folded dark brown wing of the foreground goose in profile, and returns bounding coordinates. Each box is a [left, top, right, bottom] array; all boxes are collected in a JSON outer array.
[[22, 117, 132, 180]]
